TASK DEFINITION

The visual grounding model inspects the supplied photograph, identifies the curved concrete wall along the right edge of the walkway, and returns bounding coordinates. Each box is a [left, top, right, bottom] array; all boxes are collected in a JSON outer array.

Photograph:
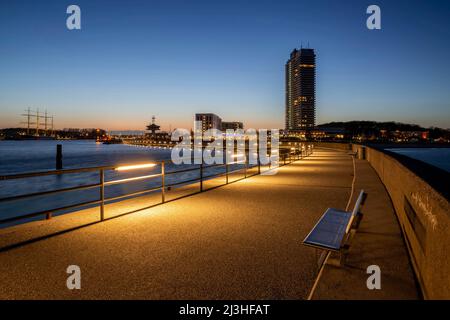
[[353, 145, 450, 299]]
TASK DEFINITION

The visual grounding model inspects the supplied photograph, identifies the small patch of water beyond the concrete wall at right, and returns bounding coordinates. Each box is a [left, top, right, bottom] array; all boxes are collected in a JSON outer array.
[[388, 148, 450, 172]]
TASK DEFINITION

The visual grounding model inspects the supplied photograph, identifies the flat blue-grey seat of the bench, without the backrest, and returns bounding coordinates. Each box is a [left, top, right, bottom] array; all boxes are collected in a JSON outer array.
[[303, 208, 352, 251]]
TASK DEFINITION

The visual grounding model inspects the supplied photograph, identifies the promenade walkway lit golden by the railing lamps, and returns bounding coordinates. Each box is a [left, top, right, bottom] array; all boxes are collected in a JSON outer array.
[[0, 150, 416, 299]]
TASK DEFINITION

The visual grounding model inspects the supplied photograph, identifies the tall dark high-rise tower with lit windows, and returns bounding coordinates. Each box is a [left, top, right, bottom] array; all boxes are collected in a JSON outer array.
[[285, 48, 316, 132]]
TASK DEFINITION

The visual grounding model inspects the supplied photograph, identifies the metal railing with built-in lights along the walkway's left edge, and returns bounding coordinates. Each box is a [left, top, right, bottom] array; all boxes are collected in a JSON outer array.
[[0, 144, 313, 226]]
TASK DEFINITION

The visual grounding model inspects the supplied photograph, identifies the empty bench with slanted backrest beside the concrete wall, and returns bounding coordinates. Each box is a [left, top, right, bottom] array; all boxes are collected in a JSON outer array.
[[303, 190, 367, 265]]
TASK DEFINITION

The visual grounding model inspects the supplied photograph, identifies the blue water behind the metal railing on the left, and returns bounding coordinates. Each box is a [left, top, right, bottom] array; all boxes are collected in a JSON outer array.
[[0, 140, 239, 228]]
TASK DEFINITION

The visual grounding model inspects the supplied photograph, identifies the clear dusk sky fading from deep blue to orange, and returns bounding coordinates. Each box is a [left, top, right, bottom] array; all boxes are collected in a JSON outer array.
[[0, 0, 450, 130]]
